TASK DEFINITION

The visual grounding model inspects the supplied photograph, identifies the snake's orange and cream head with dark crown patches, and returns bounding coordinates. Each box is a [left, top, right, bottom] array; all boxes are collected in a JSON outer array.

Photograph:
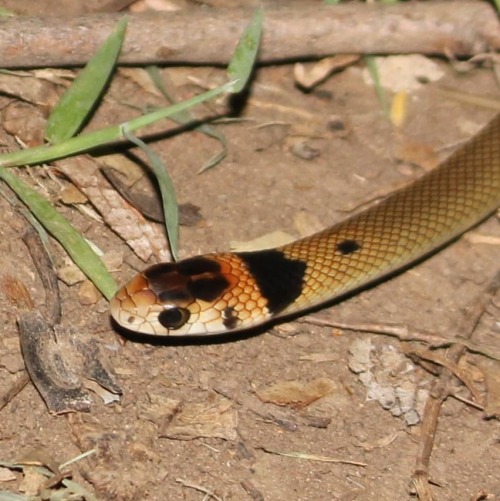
[[110, 254, 268, 336]]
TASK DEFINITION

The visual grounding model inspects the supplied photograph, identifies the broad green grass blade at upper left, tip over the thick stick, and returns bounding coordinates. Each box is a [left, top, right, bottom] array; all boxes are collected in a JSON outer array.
[[45, 17, 127, 143]]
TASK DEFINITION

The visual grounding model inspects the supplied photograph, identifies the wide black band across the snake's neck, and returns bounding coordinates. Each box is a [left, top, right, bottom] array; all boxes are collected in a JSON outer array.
[[237, 249, 307, 314]]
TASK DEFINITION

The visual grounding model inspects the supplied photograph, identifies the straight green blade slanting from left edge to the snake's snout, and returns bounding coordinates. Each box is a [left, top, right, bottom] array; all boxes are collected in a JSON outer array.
[[0, 169, 117, 300]]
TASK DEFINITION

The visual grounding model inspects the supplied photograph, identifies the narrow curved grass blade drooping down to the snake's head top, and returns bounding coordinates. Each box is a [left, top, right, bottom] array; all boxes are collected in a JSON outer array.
[[123, 127, 179, 261]]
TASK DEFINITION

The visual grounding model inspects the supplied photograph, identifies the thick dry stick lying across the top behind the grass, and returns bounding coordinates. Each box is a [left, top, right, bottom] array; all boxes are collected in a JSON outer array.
[[0, 1, 500, 68]]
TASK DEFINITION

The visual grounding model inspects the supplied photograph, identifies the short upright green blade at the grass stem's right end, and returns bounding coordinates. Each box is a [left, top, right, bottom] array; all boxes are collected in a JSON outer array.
[[227, 9, 264, 93]]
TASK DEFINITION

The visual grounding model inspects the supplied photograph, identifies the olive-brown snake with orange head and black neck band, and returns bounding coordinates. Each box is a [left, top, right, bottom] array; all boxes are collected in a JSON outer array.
[[110, 115, 500, 336]]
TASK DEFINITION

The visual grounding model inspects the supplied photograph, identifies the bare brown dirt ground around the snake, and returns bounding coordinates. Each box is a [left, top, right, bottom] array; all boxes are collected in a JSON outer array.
[[0, 2, 500, 501]]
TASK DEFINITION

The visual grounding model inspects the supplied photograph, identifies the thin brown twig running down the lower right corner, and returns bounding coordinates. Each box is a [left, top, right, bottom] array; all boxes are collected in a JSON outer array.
[[412, 272, 500, 501]]
